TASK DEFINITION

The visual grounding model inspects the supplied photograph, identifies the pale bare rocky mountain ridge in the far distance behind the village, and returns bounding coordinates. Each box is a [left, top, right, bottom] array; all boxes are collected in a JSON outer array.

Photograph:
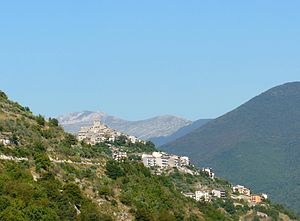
[[57, 111, 192, 140]]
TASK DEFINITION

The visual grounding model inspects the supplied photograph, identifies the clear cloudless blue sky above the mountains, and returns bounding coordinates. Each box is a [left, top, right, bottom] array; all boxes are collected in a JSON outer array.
[[0, 0, 300, 120]]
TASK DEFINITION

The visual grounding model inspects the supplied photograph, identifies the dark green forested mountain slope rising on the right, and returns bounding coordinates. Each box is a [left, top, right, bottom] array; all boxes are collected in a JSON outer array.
[[161, 82, 300, 213]]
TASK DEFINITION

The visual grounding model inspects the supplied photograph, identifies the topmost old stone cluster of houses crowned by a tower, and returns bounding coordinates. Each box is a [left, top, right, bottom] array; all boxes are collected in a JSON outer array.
[[78, 121, 142, 145]]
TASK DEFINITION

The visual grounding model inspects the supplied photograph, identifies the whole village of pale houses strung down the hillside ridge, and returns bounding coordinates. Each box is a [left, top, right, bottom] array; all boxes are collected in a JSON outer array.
[[78, 121, 274, 218]]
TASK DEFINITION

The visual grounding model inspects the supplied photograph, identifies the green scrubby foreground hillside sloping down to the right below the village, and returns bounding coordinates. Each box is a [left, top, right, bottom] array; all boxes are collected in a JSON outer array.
[[0, 92, 296, 221]]
